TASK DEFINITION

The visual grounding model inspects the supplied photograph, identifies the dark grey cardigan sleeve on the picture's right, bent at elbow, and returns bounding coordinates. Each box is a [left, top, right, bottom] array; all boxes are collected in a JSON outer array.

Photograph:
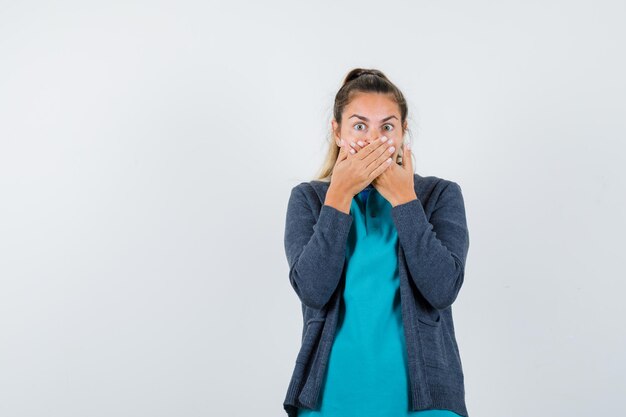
[[392, 181, 469, 310]]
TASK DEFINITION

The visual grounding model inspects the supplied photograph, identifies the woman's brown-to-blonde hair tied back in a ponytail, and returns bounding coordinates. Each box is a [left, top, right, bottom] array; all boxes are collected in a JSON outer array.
[[315, 68, 411, 182]]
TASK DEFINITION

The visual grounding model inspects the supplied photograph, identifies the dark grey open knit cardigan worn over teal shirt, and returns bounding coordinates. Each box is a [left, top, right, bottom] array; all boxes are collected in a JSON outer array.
[[283, 174, 469, 417]]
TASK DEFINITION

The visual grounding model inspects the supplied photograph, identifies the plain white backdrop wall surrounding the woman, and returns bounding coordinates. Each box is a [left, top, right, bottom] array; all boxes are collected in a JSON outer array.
[[0, 1, 626, 417]]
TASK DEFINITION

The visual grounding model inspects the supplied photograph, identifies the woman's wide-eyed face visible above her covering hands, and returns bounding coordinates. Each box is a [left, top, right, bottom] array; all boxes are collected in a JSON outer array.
[[332, 92, 406, 161]]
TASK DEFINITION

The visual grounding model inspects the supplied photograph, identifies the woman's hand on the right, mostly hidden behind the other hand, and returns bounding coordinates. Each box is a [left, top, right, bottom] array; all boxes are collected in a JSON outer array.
[[372, 143, 417, 207]]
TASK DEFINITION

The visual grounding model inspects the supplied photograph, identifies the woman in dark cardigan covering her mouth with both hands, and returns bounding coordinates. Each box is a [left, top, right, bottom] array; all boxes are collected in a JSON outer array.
[[283, 68, 469, 417]]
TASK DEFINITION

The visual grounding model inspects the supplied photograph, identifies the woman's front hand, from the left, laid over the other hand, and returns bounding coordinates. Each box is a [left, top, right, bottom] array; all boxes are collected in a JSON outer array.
[[324, 136, 395, 213]]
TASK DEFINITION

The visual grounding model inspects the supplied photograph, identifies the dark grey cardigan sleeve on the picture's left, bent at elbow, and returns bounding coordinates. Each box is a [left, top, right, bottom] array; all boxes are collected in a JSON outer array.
[[285, 183, 352, 309]]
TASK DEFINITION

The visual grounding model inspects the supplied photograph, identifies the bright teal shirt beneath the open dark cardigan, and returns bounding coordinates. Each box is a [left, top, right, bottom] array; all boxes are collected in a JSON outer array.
[[298, 184, 460, 417]]
